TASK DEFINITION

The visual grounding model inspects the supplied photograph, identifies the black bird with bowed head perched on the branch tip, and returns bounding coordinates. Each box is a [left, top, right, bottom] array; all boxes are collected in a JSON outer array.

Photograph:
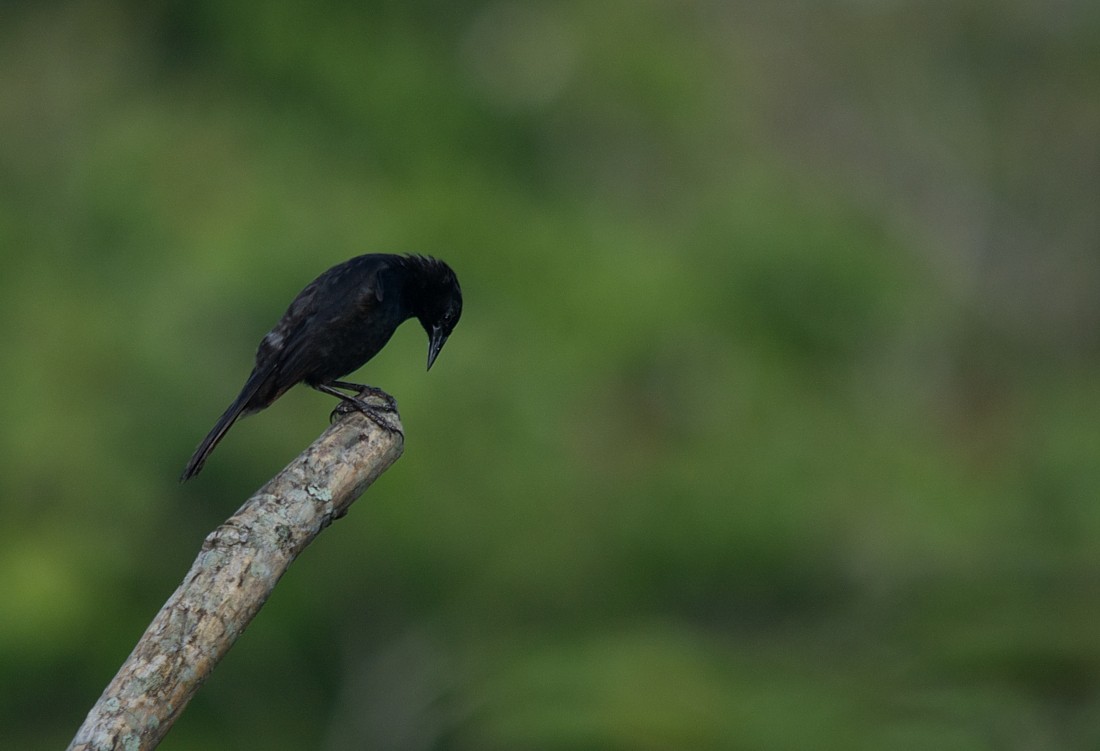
[[179, 253, 462, 482]]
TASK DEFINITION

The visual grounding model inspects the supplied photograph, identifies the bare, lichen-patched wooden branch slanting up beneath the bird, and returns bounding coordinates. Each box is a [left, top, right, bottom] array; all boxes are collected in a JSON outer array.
[[68, 402, 404, 751]]
